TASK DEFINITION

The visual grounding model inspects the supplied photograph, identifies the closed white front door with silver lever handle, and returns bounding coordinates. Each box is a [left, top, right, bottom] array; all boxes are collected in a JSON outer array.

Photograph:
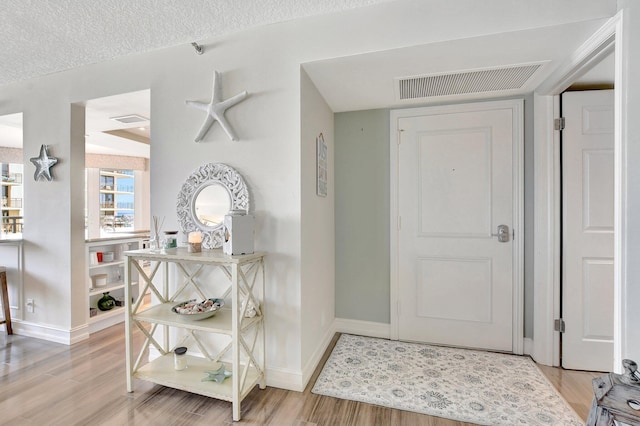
[[392, 101, 522, 352]]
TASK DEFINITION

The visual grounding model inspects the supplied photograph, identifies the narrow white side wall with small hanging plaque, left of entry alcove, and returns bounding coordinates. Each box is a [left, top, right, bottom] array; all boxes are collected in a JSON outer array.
[[300, 70, 335, 390]]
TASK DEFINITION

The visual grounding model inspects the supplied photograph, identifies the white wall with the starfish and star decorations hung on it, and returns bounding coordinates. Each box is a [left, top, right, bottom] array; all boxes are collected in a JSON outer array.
[[0, 0, 620, 389]]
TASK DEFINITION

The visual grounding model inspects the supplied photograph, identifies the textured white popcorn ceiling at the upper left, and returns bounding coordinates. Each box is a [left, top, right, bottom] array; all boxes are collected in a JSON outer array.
[[0, 0, 389, 86]]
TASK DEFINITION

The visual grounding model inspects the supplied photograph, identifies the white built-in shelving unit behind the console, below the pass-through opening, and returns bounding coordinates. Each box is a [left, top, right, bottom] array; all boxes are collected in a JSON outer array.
[[85, 237, 143, 333]]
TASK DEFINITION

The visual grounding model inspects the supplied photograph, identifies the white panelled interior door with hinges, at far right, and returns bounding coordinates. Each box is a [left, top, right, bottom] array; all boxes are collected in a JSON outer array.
[[562, 90, 614, 371]]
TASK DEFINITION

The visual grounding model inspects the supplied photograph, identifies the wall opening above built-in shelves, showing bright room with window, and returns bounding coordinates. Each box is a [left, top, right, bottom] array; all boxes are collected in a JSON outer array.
[[85, 90, 151, 239]]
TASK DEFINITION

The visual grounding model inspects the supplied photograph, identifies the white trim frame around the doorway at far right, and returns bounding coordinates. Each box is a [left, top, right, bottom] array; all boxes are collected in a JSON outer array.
[[531, 11, 628, 368]]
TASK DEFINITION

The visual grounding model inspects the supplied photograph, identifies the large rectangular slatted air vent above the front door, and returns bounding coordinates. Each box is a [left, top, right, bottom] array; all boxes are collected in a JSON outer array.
[[398, 64, 542, 100]]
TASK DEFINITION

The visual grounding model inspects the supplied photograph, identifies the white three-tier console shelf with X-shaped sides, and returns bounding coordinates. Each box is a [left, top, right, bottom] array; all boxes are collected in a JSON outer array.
[[125, 247, 266, 421]]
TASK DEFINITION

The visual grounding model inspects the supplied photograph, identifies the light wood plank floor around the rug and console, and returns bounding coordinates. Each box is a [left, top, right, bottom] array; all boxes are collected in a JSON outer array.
[[0, 324, 601, 426]]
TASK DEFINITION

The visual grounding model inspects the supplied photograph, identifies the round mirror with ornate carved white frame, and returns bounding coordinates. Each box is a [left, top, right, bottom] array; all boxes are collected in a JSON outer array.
[[176, 163, 249, 249]]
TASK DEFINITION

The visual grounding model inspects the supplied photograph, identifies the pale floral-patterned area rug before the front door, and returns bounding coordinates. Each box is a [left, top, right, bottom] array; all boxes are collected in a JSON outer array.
[[311, 334, 584, 426]]
